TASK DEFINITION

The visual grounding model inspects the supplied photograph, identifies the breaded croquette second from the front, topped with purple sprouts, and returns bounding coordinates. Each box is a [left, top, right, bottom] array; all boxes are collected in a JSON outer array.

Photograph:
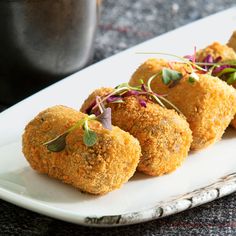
[[81, 88, 192, 176]]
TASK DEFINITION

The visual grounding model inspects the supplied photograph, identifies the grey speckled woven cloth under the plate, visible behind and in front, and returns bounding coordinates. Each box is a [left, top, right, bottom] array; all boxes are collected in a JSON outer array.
[[0, 0, 236, 236]]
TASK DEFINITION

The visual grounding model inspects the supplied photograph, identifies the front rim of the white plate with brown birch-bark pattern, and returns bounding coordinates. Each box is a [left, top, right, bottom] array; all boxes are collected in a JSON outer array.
[[0, 172, 236, 227]]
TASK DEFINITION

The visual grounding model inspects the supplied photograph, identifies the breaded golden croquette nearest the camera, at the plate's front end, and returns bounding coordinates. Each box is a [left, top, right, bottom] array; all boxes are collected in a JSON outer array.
[[23, 106, 141, 194]]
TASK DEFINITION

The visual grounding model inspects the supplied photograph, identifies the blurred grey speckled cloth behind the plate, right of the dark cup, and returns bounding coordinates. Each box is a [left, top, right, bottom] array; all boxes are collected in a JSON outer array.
[[94, 0, 236, 61]]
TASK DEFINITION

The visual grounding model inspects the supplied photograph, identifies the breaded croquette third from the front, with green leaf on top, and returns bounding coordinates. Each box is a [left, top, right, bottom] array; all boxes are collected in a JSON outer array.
[[129, 59, 236, 150]]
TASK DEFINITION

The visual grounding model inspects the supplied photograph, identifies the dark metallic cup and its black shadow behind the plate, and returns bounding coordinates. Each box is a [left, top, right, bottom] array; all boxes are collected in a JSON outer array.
[[0, 0, 99, 104]]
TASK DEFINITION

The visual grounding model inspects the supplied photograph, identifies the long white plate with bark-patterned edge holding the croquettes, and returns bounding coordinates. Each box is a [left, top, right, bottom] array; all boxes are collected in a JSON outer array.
[[0, 8, 236, 226]]
